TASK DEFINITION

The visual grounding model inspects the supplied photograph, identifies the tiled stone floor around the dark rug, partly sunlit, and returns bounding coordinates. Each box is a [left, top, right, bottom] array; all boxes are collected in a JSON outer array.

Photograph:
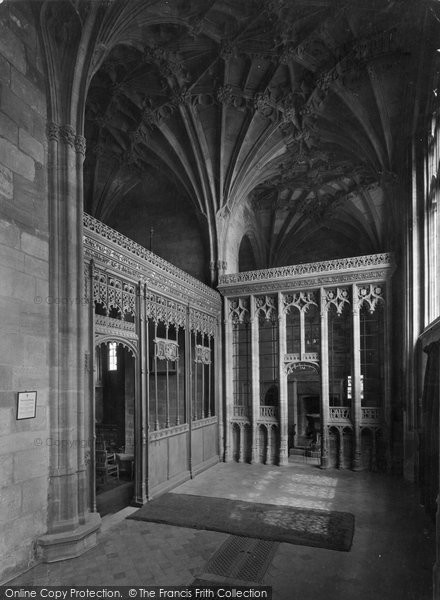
[[10, 463, 435, 600]]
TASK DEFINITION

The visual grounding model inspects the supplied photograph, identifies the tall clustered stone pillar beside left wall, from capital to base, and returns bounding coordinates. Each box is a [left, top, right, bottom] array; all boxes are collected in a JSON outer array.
[[38, 123, 100, 562]]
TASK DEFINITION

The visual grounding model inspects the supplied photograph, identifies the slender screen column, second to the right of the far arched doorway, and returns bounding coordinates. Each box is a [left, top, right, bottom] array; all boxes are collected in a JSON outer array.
[[351, 284, 362, 471]]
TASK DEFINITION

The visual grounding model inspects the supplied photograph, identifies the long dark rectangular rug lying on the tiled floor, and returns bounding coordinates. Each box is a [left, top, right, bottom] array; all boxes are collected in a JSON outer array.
[[127, 493, 354, 551]]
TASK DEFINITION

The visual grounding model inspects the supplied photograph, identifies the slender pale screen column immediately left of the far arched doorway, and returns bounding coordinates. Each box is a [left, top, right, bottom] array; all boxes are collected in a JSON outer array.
[[278, 292, 289, 465]]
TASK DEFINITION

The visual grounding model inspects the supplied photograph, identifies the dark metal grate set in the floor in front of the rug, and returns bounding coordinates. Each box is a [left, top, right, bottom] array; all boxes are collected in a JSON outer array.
[[205, 535, 278, 582]]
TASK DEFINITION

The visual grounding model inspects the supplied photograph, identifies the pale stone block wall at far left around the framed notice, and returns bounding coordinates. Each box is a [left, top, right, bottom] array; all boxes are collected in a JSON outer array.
[[0, 2, 49, 581]]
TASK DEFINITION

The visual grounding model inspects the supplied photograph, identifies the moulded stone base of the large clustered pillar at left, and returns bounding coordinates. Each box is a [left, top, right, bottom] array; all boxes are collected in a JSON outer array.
[[37, 513, 101, 563]]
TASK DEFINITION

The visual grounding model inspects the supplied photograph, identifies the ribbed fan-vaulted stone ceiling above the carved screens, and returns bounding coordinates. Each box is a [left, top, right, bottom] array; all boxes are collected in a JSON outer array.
[[81, 0, 418, 282]]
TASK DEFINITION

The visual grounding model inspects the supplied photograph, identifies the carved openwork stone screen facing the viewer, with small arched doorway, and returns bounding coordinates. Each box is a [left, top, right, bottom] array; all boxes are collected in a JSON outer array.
[[219, 254, 392, 470]]
